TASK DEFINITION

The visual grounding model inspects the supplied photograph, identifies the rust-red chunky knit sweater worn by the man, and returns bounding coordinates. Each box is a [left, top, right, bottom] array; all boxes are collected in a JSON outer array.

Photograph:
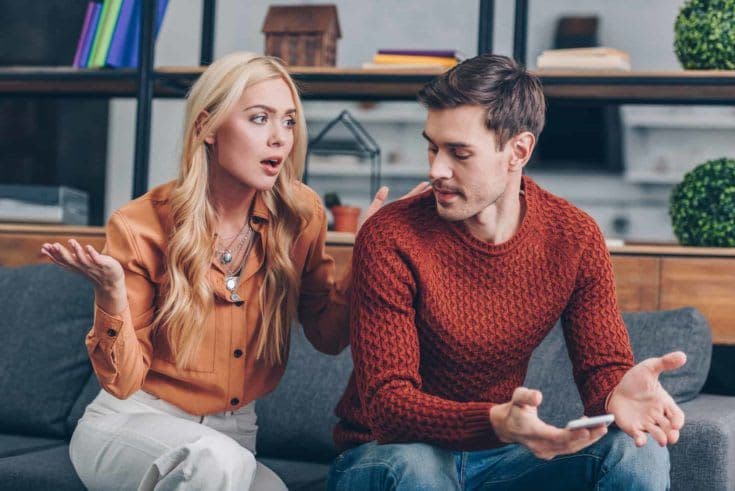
[[334, 177, 633, 450]]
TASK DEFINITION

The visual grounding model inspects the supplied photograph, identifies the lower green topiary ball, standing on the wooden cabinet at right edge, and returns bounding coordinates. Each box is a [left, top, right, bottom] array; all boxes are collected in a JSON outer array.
[[669, 158, 735, 247]]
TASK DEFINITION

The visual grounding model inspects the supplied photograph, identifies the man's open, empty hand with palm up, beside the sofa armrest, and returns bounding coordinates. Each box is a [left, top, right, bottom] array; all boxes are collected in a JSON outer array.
[[607, 351, 686, 447]]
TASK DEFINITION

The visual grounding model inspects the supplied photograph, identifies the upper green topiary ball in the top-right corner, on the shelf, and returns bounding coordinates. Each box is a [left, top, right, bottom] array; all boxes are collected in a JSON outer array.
[[674, 0, 735, 70]]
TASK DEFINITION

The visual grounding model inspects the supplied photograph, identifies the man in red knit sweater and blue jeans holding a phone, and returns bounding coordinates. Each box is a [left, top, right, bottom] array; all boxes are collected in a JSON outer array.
[[329, 55, 686, 490]]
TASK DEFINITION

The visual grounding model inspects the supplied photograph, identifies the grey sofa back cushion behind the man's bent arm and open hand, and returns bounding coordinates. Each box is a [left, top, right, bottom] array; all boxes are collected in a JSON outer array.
[[525, 307, 712, 425]]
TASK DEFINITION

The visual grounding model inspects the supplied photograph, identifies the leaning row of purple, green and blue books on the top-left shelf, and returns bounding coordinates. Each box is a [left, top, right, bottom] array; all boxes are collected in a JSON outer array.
[[73, 0, 168, 68]]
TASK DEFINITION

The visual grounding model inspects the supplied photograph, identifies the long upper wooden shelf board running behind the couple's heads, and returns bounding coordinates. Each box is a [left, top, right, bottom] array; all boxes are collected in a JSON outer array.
[[5, 67, 735, 104]]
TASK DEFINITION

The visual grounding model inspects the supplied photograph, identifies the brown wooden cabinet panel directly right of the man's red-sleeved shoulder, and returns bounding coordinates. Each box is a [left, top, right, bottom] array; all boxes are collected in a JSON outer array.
[[612, 255, 660, 312]]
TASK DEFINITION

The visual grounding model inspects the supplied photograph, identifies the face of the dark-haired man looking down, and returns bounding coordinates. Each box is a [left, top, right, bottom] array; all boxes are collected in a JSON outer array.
[[424, 105, 512, 221]]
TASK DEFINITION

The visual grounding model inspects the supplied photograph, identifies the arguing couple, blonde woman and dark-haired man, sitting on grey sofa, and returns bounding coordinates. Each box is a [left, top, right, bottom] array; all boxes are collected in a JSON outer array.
[[42, 54, 685, 490]]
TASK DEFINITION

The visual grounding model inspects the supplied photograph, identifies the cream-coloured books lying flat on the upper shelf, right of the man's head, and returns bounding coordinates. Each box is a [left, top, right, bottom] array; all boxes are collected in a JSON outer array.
[[536, 47, 630, 71]]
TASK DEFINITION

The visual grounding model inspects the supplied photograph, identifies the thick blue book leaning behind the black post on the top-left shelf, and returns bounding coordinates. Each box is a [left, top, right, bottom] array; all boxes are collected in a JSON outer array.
[[105, 0, 168, 68]]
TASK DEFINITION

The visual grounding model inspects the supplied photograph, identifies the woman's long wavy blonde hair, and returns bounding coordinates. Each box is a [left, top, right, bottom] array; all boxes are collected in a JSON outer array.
[[154, 53, 311, 368]]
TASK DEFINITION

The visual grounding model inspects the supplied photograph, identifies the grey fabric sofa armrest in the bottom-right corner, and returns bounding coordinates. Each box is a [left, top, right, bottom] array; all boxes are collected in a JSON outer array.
[[670, 394, 735, 491]]
